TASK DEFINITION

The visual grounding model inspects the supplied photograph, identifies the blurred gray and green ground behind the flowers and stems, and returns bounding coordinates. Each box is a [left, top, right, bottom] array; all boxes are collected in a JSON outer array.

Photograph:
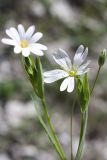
[[0, 0, 107, 160]]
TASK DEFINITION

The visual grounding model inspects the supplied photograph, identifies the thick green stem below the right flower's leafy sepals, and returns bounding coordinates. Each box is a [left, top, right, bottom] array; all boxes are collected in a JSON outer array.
[[75, 109, 88, 160]]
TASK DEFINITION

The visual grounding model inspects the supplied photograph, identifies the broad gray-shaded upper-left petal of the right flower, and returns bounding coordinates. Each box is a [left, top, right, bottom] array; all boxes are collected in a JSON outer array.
[[53, 49, 72, 70]]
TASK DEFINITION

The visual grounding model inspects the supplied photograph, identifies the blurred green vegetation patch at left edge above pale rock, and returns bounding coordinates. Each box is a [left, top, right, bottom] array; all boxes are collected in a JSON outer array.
[[0, 80, 31, 102]]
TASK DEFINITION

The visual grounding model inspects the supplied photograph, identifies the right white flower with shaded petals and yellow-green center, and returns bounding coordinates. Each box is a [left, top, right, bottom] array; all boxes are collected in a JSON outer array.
[[44, 45, 90, 92]]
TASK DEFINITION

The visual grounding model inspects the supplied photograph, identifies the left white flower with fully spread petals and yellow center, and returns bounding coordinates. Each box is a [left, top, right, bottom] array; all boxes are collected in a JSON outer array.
[[1, 24, 47, 57]]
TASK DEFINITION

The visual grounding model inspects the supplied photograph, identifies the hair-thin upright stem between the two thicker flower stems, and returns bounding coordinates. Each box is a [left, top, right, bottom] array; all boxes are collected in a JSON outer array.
[[71, 98, 76, 160]]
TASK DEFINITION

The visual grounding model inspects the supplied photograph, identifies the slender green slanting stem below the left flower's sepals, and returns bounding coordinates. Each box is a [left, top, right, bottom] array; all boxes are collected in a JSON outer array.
[[41, 98, 66, 160]]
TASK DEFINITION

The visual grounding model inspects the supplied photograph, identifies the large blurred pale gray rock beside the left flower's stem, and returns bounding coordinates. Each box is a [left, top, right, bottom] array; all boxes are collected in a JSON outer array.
[[6, 100, 36, 127]]
